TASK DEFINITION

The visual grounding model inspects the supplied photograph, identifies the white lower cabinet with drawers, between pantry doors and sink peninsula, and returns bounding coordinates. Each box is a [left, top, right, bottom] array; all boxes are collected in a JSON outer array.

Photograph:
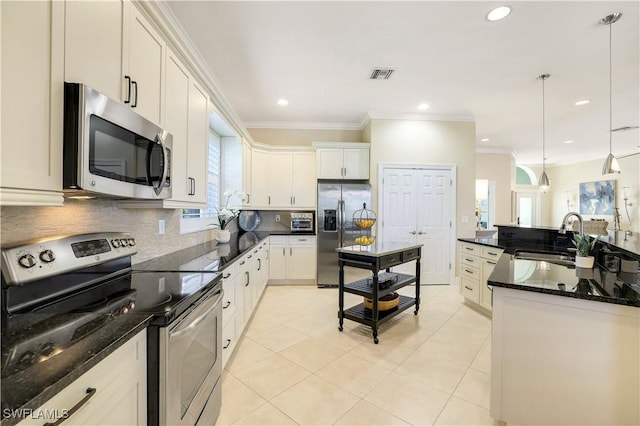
[[459, 242, 504, 312]]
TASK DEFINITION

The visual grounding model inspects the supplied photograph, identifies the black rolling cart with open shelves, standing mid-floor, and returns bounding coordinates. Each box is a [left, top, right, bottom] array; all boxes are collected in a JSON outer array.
[[336, 241, 422, 344]]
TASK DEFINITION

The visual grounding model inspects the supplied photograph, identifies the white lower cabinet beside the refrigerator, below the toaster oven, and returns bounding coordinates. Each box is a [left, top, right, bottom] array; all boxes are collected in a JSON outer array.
[[269, 235, 316, 284]]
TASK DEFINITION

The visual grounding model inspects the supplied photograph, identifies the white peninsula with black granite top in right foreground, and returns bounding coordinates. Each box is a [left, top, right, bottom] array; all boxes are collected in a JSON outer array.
[[488, 254, 640, 425]]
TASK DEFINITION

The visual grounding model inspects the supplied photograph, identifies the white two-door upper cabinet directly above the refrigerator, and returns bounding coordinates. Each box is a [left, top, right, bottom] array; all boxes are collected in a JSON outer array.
[[314, 142, 369, 180]]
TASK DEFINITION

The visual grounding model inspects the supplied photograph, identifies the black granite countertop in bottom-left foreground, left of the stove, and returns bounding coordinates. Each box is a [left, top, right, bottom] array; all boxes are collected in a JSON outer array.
[[1, 313, 151, 426]]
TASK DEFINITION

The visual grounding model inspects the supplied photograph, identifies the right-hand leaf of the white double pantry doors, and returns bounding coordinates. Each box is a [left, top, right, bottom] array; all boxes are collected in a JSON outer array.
[[415, 170, 451, 284]]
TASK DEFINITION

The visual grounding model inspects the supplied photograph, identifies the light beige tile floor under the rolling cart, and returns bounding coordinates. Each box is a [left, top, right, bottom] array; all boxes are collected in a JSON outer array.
[[217, 286, 497, 425]]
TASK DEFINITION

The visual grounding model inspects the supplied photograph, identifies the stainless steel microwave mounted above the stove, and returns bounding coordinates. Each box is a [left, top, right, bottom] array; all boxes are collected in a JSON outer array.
[[63, 83, 173, 199]]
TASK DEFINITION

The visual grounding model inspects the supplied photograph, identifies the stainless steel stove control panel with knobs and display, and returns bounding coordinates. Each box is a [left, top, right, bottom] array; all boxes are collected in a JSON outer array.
[[2, 232, 138, 285]]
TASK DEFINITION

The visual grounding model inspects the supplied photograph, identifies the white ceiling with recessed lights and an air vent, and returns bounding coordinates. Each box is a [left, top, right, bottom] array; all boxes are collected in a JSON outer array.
[[168, 0, 640, 165]]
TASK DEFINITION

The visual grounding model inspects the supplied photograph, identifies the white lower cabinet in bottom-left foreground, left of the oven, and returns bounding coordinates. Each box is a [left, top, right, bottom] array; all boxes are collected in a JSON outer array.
[[20, 330, 147, 425]]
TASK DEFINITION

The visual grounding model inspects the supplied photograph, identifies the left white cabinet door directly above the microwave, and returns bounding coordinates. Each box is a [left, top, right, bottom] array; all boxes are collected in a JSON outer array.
[[64, 0, 125, 100]]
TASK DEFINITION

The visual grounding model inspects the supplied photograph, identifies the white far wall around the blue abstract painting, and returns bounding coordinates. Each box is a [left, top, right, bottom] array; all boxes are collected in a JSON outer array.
[[542, 154, 640, 232]]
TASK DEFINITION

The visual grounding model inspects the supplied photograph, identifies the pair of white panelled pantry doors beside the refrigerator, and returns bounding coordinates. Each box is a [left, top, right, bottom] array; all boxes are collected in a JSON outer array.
[[380, 168, 452, 284]]
